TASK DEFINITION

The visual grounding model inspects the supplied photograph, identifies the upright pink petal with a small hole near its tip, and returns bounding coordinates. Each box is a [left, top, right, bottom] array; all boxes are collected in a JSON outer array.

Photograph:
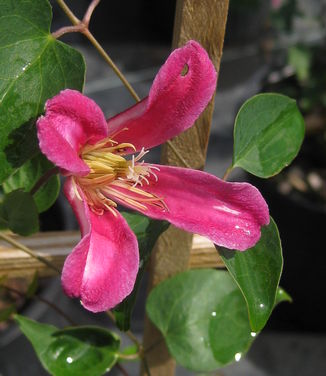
[[108, 41, 217, 151]]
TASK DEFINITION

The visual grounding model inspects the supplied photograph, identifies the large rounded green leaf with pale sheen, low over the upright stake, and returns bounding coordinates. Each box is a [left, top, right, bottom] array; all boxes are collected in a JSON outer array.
[[146, 270, 253, 372]]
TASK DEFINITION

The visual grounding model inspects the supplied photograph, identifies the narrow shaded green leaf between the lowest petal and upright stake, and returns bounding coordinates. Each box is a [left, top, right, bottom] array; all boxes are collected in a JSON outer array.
[[113, 212, 169, 331]]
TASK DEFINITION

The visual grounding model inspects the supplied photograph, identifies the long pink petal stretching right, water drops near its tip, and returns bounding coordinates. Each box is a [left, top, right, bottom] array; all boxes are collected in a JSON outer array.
[[112, 165, 269, 250]]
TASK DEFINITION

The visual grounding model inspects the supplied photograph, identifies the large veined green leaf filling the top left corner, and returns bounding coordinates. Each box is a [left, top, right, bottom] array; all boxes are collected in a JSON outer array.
[[0, 0, 85, 182]]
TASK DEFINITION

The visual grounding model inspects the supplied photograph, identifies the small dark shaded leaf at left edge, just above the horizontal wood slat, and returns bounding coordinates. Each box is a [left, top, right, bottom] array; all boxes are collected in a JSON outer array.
[[0, 189, 39, 236]]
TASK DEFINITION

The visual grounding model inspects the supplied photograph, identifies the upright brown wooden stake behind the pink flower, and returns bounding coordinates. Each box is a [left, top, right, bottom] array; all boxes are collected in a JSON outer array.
[[142, 0, 229, 376]]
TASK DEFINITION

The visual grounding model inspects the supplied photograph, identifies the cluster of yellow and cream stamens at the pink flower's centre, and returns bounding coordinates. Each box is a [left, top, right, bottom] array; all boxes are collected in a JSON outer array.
[[73, 138, 167, 215]]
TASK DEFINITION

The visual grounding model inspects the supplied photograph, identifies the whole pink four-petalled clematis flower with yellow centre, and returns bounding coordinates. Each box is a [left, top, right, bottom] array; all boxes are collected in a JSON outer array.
[[37, 41, 269, 312]]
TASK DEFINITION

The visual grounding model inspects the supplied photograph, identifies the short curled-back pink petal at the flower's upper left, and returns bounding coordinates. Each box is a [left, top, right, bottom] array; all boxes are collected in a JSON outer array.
[[37, 89, 108, 175]]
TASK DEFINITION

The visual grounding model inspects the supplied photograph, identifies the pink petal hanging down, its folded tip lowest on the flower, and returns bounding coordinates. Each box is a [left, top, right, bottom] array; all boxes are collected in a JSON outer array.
[[62, 178, 139, 312]]
